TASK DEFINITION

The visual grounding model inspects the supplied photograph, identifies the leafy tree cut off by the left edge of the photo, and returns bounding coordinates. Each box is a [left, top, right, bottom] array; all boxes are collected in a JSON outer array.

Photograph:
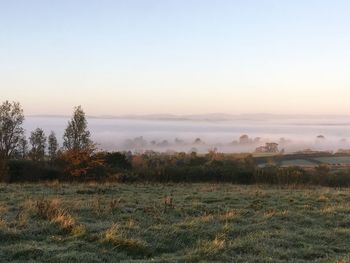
[[0, 101, 24, 159]]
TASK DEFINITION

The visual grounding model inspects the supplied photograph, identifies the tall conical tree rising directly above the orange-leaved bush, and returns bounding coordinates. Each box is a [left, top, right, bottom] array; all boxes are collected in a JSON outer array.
[[63, 106, 92, 151]]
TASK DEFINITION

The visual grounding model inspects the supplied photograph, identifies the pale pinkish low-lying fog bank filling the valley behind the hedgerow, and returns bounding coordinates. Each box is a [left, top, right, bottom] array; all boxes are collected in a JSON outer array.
[[24, 116, 350, 153]]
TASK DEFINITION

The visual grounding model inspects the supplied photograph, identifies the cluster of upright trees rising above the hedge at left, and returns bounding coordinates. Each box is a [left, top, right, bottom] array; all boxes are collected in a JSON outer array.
[[0, 101, 93, 161]]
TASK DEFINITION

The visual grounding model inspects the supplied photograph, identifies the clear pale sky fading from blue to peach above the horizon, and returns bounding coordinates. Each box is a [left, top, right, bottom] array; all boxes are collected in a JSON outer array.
[[0, 0, 350, 115]]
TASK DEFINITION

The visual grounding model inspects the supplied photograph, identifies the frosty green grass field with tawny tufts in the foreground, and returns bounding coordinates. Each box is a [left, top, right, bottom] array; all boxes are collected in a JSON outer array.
[[0, 183, 350, 262]]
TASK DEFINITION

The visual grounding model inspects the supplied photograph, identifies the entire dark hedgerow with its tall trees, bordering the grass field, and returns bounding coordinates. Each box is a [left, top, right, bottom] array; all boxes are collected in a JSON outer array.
[[0, 101, 350, 186]]
